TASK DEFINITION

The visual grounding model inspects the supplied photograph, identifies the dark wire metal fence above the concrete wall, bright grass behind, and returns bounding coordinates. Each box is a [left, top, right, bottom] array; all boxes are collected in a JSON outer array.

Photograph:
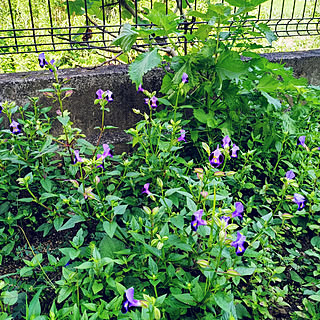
[[0, 0, 320, 55]]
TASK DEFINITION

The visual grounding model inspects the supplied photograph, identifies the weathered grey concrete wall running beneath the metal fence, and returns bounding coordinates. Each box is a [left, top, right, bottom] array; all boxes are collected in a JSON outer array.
[[0, 50, 320, 152]]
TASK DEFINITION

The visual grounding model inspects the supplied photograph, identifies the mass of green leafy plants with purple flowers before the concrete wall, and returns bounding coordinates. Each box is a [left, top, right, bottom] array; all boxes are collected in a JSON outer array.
[[0, 0, 320, 320]]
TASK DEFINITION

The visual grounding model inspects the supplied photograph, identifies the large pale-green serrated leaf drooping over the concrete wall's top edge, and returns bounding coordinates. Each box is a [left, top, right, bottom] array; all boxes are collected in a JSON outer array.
[[129, 48, 161, 88]]
